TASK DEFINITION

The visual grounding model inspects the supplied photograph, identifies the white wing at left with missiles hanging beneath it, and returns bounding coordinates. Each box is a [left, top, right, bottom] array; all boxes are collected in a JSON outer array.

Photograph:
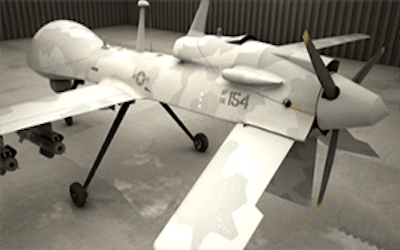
[[0, 78, 143, 135]]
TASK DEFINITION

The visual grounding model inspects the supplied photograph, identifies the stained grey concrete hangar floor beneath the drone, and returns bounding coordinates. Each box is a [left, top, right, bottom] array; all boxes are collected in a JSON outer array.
[[0, 26, 400, 250]]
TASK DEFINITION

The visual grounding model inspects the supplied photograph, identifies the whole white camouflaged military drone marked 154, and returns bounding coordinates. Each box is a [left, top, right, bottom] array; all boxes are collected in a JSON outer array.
[[0, 0, 388, 249]]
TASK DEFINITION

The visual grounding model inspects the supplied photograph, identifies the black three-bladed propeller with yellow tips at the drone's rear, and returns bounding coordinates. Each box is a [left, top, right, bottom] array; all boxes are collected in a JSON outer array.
[[303, 31, 384, 207]]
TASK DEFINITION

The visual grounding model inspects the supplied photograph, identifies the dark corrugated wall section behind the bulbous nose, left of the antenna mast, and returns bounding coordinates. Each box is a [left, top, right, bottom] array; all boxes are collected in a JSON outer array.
[[0, 0, 128, 40]]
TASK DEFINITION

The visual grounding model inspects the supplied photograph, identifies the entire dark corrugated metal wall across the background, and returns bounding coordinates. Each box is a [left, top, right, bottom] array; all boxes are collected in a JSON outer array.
[[0, 0, 400, 66]]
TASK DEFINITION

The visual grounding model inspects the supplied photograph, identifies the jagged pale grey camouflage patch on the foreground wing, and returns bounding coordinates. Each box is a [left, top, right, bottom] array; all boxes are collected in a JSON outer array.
[[176, 141, 247, 249]]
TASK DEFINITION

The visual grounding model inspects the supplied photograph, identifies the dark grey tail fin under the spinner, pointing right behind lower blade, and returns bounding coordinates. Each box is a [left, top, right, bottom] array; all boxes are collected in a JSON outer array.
[[318, 129, 379, 158]]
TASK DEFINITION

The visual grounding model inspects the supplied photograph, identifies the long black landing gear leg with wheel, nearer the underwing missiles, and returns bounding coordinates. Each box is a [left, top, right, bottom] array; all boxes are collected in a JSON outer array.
[[69, 101, 134, 207]]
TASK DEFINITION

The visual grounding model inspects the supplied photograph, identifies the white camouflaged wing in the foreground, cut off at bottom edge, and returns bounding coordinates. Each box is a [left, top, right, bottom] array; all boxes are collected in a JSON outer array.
[[154, 124, 294, 250]]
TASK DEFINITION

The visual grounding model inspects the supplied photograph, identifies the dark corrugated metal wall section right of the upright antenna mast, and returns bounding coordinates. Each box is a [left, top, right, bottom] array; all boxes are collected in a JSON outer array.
[[145, 0, 400, 66]]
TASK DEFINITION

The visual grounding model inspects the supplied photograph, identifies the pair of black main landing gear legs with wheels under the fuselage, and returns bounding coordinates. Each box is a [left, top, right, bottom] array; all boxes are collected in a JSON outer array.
[[69, 101, 208, 208]]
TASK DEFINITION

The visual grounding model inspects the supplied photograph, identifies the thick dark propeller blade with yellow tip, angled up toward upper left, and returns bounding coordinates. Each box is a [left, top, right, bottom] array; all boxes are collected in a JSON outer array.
[[304, 31, 339, 100]]
